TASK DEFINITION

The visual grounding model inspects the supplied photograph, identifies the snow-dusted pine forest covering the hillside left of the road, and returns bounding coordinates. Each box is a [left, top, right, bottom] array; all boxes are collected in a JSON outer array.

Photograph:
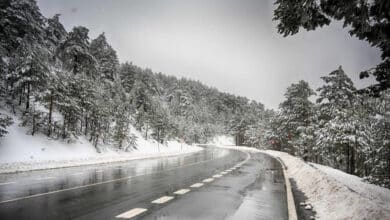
[[0, 0, 272, 150]]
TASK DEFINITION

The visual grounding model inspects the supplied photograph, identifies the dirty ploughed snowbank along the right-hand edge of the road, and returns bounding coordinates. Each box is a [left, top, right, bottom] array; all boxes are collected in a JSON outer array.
[[265, 150, 390, 220]]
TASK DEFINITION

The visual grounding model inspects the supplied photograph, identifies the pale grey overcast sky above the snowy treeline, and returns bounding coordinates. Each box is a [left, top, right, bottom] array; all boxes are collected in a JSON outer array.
[[38, 0, 380, 108]]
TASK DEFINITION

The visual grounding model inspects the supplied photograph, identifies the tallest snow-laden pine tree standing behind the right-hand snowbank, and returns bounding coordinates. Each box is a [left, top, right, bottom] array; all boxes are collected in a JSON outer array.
[[316, 66, 369, 174]]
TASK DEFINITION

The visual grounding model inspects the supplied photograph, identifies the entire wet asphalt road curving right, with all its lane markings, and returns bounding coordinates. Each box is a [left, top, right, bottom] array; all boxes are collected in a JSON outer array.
[[0, 146, 287, 220]]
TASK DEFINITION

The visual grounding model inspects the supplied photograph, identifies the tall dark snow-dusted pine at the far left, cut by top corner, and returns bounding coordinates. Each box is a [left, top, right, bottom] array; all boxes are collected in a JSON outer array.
[[0, 0, 44, 115]]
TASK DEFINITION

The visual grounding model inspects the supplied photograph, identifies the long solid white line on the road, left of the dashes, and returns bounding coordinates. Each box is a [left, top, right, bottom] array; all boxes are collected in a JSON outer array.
[[0, 158, 217, 204]]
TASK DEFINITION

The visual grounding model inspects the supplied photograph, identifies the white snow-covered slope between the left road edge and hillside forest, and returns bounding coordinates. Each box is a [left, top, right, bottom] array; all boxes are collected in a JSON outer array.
[[0, 113, 202, 173]]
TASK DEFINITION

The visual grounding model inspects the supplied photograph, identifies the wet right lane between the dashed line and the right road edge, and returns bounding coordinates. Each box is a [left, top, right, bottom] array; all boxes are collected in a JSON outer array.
[[144, 153, 288, 220]]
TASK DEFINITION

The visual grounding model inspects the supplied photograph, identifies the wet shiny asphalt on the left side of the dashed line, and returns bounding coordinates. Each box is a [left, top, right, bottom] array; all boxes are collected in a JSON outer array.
[[0, 148, 241, 219]]
